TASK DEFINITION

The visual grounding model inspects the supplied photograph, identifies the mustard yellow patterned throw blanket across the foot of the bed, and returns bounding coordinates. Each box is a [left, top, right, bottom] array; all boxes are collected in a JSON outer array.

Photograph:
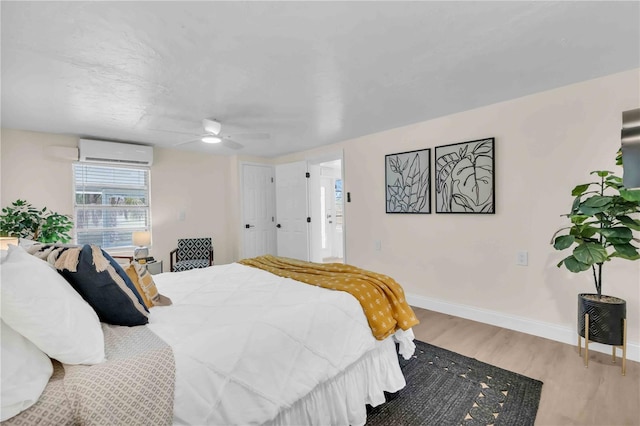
[[239, 255, 419, 340]]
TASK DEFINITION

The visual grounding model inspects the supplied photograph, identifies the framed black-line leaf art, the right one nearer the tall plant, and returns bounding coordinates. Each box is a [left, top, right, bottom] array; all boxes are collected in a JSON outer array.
[[435, 138, 496, 214]]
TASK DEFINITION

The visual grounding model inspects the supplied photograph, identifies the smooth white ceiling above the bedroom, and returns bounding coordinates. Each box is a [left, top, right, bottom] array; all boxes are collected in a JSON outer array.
[[0, 1, 640, 157]]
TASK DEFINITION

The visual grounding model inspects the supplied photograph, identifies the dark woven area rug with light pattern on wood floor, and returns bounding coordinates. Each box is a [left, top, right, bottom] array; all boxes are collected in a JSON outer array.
[[367, 340, 542, 426]]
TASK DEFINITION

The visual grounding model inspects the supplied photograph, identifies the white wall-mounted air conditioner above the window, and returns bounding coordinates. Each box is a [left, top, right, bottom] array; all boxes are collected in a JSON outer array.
[[78, 139, 153, 166]]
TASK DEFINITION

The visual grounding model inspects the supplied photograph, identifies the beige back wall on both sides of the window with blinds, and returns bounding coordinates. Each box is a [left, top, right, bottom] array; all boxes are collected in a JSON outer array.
[[0, 129, 238, 271]]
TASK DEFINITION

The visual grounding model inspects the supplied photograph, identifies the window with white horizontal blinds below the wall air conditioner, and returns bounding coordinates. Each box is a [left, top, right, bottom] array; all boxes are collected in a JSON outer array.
[[73, 163, 150, 249]]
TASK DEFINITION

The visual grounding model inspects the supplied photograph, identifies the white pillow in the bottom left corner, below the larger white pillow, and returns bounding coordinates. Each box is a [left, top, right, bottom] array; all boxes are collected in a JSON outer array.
[[0, 321, 53, 421]]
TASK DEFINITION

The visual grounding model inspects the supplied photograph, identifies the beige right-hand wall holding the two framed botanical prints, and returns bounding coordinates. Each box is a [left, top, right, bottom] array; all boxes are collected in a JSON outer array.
[[327, 70, 640, 342]]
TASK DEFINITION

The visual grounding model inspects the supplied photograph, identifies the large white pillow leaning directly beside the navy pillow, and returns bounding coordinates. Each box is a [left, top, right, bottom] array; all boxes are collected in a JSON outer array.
[[0, 246, 104, 364]]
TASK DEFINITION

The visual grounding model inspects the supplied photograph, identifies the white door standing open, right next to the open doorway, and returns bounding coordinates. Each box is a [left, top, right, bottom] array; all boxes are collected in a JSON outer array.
[[276, 161, 309, 260]]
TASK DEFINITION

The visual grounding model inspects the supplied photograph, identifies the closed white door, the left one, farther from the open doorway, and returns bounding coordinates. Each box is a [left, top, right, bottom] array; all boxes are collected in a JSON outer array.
[[242, 164, 276, 258]]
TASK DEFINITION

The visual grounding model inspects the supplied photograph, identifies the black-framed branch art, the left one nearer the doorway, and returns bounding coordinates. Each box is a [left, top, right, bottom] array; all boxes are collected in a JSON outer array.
[[384, 148, 431, 214]]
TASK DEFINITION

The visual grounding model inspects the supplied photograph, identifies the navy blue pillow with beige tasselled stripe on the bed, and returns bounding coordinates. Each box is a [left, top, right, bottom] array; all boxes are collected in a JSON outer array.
[[58, 244, 149, 326]]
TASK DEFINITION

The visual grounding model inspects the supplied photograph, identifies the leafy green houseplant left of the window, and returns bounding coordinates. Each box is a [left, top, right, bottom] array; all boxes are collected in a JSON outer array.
[[0, 200, 73, 243]]
